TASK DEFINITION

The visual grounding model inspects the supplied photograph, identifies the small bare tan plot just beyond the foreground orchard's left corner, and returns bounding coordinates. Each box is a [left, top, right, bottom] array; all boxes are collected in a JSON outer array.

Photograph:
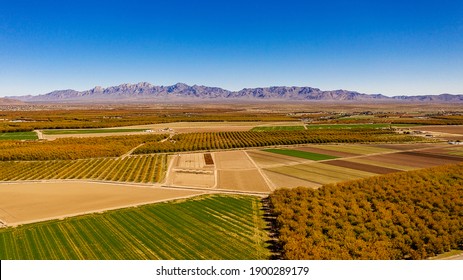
[[217, 169, 270, 192]]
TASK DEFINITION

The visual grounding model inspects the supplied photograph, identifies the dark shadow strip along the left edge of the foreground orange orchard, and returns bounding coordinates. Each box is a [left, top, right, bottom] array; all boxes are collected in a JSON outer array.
[[261, 197, 283, 260]]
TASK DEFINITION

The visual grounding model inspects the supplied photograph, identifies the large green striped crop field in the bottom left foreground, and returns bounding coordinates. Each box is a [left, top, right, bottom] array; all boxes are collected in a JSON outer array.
[[0, 195, 270, 260]]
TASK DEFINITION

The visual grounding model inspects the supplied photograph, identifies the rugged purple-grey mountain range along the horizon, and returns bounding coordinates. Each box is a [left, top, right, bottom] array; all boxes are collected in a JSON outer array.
[[11, 82, 463, 103]]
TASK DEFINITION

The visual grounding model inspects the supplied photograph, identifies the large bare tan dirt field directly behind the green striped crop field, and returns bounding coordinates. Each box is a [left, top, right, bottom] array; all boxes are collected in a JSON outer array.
[[0, 181, 204, 226]]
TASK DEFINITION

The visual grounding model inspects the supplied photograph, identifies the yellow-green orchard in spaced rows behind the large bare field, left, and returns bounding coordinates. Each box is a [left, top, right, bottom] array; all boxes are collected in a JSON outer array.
[[0, 155, 167, 183]]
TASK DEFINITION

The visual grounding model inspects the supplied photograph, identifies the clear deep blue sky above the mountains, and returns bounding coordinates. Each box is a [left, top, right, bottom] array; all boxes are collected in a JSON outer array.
[[0, 0, 463, 96]]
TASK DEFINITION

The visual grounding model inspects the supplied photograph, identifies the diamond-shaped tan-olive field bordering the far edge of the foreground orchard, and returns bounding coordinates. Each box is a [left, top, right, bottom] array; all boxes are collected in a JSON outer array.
[[266, 163, 376, 185]]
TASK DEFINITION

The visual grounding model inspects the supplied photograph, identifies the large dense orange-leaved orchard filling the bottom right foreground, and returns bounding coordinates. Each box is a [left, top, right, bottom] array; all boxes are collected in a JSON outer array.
[[270, 164, 463, 259]]
